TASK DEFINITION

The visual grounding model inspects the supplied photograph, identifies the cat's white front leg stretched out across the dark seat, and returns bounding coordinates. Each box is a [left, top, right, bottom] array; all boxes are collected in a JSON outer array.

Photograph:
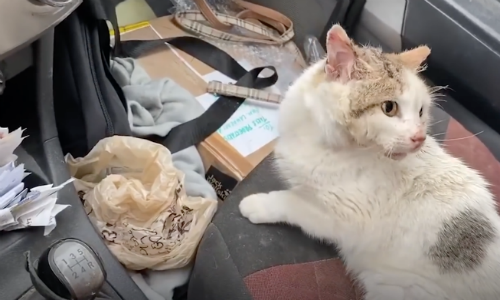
[[240, 190, 335, 241]]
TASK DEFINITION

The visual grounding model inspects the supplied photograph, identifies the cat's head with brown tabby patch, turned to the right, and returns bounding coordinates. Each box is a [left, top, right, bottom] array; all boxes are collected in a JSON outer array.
[[309, 25, 432, 159]]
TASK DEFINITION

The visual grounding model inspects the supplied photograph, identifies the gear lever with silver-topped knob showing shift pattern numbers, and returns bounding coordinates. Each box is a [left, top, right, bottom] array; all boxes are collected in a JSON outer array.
[[26, 238, 106, 300]]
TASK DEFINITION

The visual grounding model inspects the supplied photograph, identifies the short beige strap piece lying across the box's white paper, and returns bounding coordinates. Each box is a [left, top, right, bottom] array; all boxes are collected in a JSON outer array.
[[207, 80, 283, 104]]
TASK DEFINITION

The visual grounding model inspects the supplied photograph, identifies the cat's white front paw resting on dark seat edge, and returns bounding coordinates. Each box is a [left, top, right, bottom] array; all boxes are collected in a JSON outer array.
[[239, 193, 284, 224]]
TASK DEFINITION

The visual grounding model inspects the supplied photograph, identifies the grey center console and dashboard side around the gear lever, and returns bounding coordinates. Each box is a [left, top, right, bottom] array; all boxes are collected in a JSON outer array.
[[0, 0, 146, 300]]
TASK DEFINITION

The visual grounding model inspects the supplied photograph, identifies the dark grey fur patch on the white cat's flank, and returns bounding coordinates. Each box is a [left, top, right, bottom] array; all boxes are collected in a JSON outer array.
[[429, 209, 495, 273]]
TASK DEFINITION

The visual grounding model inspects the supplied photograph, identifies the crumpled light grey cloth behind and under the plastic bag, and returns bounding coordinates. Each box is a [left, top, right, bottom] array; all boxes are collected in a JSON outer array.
[[111, 58, 217, 300]]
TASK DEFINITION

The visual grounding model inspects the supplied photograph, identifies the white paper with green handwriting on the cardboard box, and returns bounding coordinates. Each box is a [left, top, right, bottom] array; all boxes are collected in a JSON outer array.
[[196, 60, 279, 156]]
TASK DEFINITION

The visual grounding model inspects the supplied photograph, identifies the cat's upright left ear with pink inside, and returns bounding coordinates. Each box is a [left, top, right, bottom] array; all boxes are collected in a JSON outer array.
[[325, 25, 356, 82]]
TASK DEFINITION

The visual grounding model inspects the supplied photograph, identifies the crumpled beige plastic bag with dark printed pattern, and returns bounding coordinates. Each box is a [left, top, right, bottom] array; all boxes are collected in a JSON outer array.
[[66, 136, 217, 270]]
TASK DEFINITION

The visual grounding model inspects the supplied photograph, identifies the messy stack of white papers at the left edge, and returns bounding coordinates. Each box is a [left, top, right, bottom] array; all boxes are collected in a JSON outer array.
[[0, 127, 73, 235]]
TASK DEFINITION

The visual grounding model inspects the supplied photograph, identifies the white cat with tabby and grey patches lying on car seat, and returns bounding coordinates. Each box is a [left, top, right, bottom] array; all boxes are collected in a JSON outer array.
[[239, 25, 500, 300]]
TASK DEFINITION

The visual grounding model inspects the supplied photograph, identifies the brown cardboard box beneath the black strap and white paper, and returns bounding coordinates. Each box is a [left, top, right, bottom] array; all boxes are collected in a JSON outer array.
[[122, 17, 302, 200]]
